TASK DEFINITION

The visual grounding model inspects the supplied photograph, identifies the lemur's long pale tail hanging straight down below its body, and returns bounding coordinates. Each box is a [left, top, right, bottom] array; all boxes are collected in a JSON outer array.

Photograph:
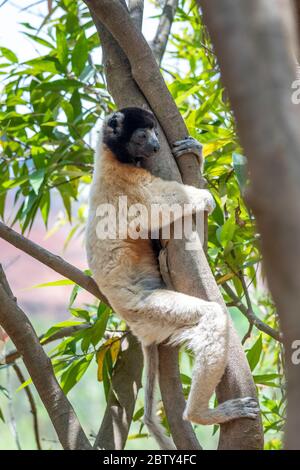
[[143, 344, 176, 450]]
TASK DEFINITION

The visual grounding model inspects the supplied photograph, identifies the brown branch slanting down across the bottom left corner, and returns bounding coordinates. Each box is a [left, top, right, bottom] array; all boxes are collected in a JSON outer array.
[[0, 271, 92, 450]]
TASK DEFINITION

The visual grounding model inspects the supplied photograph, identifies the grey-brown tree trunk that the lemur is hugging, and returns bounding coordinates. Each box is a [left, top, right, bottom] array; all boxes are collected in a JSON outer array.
[[85, 0, 263, 449]]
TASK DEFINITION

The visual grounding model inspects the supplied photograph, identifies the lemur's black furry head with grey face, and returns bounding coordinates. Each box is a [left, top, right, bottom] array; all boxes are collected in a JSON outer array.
[[103, 108, 160, 165]]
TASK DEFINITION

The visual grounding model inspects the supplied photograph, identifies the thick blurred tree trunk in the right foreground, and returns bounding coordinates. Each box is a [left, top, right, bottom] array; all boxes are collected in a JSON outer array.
[[199, 0, 300, 449]]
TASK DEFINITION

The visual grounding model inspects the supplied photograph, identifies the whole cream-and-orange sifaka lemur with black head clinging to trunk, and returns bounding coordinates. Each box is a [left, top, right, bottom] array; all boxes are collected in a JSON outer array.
[[86, 108, 259, 449]]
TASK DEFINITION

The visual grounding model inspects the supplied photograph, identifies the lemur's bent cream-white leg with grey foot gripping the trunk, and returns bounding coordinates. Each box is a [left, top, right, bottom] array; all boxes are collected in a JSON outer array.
[[132, 289, 259, 424]]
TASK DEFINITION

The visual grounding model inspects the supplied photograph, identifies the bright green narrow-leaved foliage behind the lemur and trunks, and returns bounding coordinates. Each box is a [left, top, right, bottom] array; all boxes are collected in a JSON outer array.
[[0, 0, 285, 449]]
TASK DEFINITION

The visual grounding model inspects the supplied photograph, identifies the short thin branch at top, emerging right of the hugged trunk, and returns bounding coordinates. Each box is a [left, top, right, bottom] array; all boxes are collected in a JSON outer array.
[[150, 0, 178, 64]]
